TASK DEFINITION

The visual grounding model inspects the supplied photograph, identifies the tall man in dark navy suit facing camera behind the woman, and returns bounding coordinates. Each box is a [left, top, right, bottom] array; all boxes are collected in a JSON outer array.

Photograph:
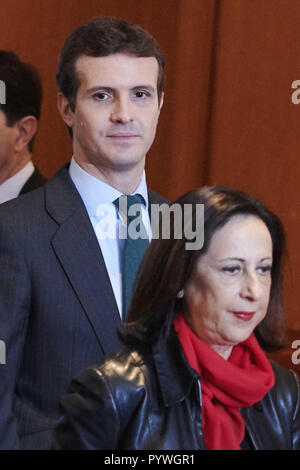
[[0, 18, 169, 449]]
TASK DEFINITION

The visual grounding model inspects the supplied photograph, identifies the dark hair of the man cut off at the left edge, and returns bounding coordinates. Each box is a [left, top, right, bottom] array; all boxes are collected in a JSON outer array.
[[0, 50, 42, 152]]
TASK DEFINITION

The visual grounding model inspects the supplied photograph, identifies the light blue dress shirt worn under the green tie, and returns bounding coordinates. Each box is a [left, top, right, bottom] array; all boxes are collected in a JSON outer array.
[[69, 157, 151, 312]]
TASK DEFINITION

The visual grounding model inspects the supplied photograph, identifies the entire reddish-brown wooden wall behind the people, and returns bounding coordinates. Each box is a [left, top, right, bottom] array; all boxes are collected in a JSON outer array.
[[0, 0, 300, 371]]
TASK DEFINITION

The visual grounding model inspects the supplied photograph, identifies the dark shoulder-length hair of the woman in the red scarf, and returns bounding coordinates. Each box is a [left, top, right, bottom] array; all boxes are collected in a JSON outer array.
[[119, 186, 286, 352]]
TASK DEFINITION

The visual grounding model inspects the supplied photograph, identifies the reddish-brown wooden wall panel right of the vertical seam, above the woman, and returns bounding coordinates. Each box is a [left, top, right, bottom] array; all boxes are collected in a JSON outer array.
[[207, 0, 300, 369]]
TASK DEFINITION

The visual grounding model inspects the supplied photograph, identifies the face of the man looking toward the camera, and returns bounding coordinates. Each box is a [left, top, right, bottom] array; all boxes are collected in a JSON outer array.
[[70, 54, 161, 171]]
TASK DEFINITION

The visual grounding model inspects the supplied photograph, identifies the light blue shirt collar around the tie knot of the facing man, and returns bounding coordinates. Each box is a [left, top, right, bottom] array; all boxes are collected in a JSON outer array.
[[69, 156, 148, 215]]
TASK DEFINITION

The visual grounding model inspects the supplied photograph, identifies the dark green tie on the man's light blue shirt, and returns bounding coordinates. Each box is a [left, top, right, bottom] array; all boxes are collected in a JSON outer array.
[[114, 194, 149, 321]]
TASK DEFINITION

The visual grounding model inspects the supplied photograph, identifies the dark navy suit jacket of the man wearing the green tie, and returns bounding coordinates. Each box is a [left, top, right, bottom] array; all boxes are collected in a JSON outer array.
[[0, 166, 167, 449]]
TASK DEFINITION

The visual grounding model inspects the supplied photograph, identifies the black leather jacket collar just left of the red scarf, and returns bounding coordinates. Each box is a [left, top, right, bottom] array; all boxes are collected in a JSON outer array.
[[152, 327, 199, 406]]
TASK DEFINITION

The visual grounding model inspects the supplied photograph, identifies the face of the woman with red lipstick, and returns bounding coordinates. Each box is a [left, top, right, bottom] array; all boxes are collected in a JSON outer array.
[[184, 215, 272, 359]]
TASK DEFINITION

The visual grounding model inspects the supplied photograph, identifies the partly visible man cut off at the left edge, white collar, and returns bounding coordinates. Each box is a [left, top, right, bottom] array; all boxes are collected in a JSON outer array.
[[0, 50, 46, 203]]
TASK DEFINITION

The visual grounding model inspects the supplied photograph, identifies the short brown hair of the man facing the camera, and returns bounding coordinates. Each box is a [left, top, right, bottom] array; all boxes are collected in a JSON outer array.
[[56, 18, 164, 111]]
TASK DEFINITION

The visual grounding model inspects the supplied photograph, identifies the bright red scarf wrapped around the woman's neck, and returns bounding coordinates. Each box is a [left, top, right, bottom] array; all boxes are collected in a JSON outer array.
[[173, 314, 275, 450]]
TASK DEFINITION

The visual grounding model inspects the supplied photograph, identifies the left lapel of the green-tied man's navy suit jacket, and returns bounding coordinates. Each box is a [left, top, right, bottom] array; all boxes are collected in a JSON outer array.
[[45, 167, 120, 353]]
